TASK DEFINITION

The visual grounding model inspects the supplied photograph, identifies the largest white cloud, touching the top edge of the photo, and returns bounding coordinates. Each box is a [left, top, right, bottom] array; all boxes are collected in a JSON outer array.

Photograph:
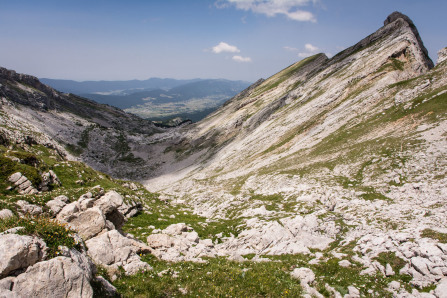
[[220, 0, 319, 22]]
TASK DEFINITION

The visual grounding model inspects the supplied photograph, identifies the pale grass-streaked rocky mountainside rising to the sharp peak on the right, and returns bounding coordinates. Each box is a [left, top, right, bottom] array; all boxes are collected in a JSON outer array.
[[146, 13, 447, 296]]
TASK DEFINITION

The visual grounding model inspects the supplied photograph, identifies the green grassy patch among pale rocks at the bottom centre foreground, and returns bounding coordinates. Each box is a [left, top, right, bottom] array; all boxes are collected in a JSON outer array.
[[114, 255, 303, 297]]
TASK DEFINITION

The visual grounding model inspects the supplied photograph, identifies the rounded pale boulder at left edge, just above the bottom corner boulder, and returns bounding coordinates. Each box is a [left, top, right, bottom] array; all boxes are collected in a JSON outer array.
[[0, 234, 47, 277]]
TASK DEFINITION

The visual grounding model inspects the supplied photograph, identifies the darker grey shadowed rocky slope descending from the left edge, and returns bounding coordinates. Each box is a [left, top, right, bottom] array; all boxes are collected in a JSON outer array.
[[0, 68, 190, 179]]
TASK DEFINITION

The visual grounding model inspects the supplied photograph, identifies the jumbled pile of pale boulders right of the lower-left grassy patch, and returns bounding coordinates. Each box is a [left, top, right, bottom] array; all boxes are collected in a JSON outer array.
[[47, 187, 151, 275]]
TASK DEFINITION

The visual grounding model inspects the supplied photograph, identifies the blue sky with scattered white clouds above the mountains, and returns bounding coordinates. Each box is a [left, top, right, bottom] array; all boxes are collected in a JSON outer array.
[[0, 0, 447, 82]]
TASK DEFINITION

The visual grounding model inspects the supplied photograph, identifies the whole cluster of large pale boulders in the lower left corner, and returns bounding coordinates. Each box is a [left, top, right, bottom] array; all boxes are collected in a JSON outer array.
[[0, 187, 152, 297]]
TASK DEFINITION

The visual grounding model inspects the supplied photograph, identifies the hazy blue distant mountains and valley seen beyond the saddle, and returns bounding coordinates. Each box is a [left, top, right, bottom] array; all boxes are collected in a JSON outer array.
[[41, 78, 250, 121]]
